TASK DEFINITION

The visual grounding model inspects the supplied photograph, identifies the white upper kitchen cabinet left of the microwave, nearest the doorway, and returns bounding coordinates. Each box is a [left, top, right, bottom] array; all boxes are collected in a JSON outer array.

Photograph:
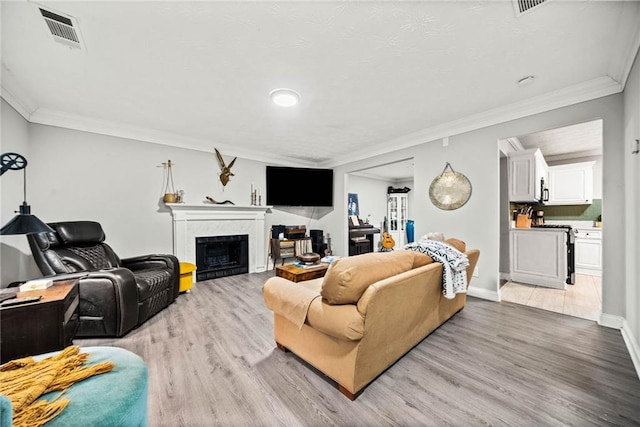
[[507, 148, 548, 203]]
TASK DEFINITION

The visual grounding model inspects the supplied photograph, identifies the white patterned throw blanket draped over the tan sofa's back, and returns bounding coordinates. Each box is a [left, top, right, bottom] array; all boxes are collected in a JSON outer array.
[[404, 240, 469, 299]]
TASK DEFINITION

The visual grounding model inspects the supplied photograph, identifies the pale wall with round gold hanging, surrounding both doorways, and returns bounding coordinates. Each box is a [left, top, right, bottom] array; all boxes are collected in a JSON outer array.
[[322, 94, 626, 310]]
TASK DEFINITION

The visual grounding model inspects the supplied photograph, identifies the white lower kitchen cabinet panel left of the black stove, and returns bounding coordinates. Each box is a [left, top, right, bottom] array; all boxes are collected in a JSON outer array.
[[509, 228, 568, 289]]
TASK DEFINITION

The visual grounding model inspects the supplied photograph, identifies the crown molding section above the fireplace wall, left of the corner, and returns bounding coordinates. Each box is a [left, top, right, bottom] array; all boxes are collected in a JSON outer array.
[[29, 108, 311, 166]]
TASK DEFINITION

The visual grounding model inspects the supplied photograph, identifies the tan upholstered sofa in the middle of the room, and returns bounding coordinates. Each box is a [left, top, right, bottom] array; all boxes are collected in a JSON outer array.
[[263, 240, 480, 400]]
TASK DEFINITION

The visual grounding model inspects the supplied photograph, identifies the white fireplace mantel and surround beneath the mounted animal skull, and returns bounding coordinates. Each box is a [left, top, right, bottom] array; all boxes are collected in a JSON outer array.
[[166, 203, 271, 273]]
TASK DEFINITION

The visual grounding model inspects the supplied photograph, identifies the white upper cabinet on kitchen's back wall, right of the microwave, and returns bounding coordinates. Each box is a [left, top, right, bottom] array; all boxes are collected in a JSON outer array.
[[545, 162, 595, 205]]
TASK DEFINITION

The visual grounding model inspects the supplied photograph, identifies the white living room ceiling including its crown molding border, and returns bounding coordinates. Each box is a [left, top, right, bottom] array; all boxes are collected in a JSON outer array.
[[0, 0, 640, 166]]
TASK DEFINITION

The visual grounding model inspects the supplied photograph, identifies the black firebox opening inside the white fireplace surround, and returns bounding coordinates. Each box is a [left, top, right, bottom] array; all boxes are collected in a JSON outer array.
[[196, 234, 249, 282]]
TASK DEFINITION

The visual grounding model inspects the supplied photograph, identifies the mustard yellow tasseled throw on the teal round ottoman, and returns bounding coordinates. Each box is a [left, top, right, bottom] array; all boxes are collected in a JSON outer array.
[[0, 346, 114, 427]]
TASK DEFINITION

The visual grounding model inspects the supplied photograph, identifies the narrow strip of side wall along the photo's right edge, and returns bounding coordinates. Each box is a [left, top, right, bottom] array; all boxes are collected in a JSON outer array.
[[624, 47, 640, 376]]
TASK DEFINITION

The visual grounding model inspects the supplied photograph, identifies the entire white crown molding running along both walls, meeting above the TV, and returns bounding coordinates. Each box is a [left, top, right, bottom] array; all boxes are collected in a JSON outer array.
[[1, 66, 622, 168]]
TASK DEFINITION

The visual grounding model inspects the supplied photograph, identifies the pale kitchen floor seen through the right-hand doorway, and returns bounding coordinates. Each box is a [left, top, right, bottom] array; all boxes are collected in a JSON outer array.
[[500, 274, 602, 320]]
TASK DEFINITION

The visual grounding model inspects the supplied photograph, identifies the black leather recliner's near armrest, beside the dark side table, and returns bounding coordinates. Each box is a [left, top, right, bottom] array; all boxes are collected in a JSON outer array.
[[78, 268, 138, 337]]
